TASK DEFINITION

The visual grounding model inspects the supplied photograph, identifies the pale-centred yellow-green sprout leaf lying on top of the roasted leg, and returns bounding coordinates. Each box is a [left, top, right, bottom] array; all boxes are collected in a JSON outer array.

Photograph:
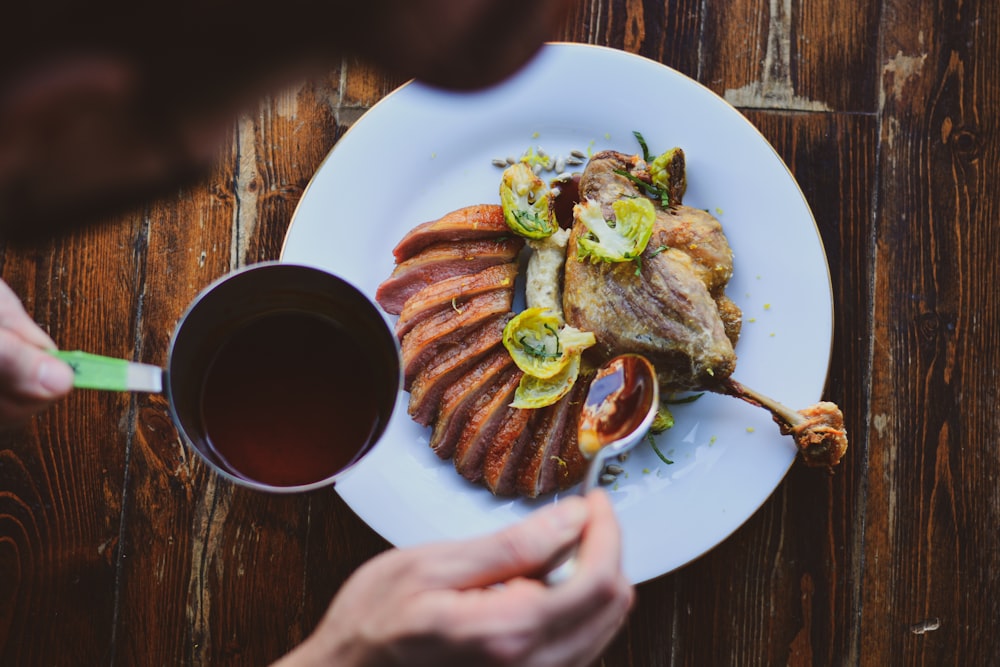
[[573, 198, 656, 263]]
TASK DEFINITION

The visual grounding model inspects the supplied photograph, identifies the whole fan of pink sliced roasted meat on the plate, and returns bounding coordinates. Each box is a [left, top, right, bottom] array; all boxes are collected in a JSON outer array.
[[376, 204, 588, 497]]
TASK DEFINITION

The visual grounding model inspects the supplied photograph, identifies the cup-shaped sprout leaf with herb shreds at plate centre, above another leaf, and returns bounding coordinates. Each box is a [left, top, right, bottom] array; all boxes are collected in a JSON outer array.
[[503, 308, 597, 380]]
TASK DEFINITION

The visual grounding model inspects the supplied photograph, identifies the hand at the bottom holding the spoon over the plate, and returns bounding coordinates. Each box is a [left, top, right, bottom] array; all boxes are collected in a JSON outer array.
[[276, 490, 633, 667]]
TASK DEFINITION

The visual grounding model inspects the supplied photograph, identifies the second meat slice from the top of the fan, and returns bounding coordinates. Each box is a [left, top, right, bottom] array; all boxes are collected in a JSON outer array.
[[375, 236, 524, 315]]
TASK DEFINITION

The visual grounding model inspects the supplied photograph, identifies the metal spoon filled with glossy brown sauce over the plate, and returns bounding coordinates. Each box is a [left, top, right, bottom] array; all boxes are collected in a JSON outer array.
[[545, 354, 660, 585]]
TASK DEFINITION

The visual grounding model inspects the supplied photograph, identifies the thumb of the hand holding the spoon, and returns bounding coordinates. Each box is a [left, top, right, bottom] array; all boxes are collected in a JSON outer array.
[[418, 496, 589, 588]]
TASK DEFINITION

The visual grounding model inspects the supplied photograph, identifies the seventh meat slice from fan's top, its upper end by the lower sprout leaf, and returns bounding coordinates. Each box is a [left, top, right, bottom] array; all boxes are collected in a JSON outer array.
[[453, 366, 524, 482]]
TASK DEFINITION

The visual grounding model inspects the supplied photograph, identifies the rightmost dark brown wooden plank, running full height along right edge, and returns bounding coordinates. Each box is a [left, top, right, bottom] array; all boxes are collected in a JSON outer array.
[[862, 0, 1000, 665]]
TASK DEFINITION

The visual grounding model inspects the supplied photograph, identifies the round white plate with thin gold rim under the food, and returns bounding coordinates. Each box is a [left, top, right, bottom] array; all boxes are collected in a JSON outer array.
[[282, 44, 833, 583]]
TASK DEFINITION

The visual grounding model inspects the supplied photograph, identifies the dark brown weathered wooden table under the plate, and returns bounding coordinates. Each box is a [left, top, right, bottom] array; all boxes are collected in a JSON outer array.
[[0, 0, 1000, 667]]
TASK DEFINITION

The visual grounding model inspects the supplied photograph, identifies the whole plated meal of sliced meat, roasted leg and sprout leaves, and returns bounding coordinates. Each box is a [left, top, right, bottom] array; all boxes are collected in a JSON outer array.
[[375, 140, 847, 497]]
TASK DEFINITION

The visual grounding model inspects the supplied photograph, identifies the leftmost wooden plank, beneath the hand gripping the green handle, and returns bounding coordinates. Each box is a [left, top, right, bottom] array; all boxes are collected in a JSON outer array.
[[0, 216, 142, 664]]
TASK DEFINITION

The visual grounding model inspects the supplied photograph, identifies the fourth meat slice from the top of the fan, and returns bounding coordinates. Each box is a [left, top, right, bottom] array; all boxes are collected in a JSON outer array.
[[400, 290, 514, 390]]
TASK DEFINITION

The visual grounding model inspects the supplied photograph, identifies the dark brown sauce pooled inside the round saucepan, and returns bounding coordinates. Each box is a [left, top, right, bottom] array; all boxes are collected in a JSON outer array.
[[201, 311, 382, 486]]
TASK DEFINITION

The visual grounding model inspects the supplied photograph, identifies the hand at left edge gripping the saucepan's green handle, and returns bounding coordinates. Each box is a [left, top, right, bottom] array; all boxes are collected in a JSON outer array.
[[0, 281, 73, 427]]
